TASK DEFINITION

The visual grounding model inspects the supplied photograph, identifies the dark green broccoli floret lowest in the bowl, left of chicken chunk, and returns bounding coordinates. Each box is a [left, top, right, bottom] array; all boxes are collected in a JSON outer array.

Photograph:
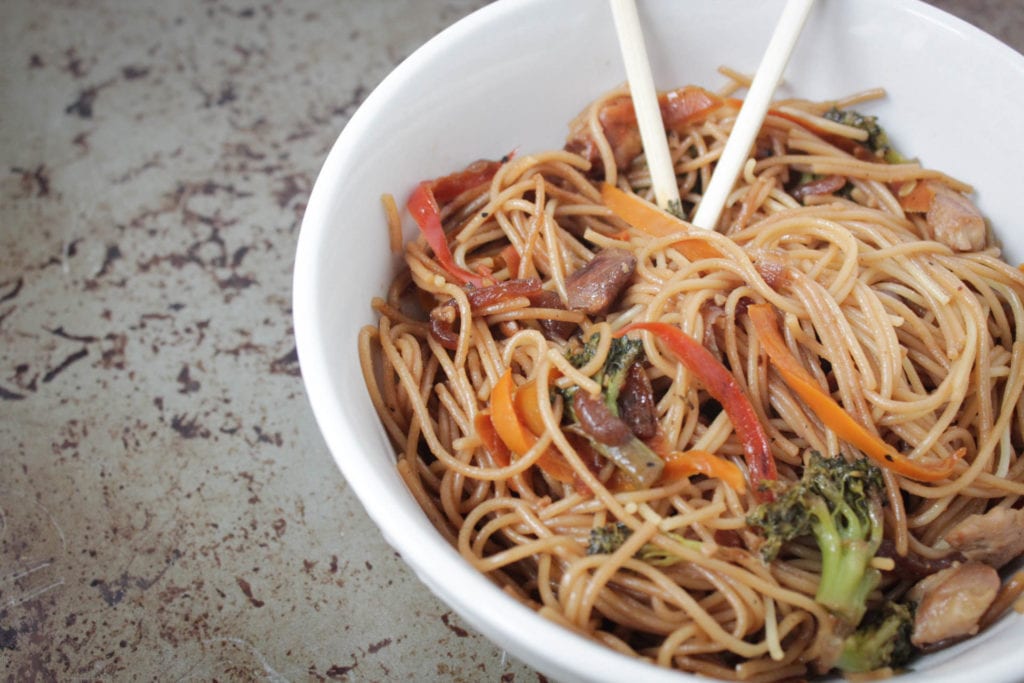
[[836, 602, 914, 674]]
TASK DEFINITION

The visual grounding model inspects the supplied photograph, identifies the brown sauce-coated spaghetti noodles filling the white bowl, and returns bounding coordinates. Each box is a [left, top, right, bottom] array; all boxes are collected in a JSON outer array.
[[359, 78, 1024, 681]]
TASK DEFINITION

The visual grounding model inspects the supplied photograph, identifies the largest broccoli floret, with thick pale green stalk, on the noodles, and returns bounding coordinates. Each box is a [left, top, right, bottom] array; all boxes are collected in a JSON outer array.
[[746, 453, 883, 626]]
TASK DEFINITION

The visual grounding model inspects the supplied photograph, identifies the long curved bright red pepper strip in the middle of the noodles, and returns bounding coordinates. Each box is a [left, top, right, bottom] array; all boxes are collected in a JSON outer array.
[[617, 323, 778, 501]]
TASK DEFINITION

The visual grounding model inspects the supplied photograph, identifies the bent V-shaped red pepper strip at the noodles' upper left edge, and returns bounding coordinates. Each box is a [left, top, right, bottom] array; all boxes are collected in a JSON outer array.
[[406, 161, 502, 287]]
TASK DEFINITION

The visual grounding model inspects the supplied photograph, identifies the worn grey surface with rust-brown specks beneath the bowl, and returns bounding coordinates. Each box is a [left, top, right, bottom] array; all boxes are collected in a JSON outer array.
[[0, 0, 1024, 681]]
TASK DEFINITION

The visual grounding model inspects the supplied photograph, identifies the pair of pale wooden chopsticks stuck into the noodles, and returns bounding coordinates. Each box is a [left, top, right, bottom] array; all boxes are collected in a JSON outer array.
[[610, 0, 814, 229]]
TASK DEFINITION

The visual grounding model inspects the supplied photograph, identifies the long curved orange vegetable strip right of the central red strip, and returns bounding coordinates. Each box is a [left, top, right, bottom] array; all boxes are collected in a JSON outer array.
[[746, 303, 961, 481]]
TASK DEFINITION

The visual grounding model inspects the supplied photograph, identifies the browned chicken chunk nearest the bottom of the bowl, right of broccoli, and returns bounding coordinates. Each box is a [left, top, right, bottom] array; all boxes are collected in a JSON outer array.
[[907, 562, 999, 647]]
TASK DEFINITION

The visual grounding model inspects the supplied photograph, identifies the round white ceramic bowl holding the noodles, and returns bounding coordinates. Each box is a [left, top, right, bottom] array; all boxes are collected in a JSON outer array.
[[294, 0, 1024, 683]]
